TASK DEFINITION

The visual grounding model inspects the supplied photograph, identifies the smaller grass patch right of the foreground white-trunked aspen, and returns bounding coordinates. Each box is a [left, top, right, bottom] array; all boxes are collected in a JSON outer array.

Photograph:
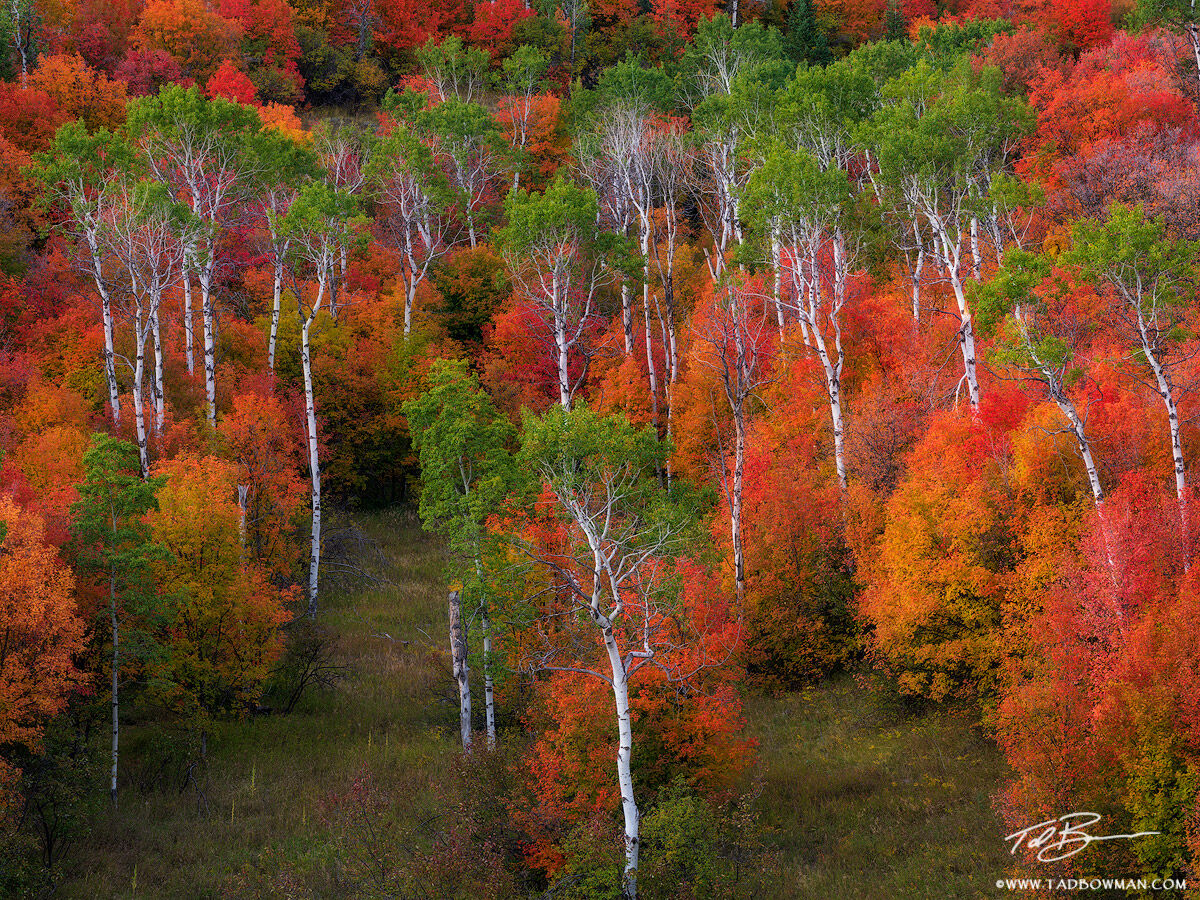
[[746, 677, 1010, 900]]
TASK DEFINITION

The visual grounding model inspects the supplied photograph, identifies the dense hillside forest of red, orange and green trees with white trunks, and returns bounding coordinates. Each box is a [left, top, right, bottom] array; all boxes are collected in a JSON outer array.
[[0, 0, 1200, 899]]
